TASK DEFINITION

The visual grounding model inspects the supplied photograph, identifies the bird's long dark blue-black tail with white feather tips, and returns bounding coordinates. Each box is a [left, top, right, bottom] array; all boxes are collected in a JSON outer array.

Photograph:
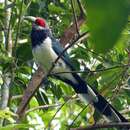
[[62, 74, 128, 122]]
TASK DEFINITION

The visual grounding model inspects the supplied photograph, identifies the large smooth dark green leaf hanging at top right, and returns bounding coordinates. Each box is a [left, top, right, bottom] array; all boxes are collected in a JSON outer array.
[[84, 0, 129, 53]]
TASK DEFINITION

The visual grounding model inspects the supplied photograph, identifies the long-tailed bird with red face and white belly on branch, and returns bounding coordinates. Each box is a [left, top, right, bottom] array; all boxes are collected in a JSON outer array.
[[24, 16, 128, 122]]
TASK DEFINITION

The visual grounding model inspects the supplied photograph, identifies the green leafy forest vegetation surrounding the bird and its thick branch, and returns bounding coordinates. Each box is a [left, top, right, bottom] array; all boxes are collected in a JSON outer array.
[[0, 0, 130, 130]]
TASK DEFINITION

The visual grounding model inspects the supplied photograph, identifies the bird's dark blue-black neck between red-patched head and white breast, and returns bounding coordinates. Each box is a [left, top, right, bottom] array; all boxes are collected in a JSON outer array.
[[31, 29, 50, 48]]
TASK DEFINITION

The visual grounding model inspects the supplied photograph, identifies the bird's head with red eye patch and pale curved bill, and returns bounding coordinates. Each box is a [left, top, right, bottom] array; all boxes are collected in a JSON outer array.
[[24, 16, 48, 30]]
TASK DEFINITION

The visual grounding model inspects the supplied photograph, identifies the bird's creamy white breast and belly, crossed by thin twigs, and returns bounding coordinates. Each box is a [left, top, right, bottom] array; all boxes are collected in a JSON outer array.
[[33, 37, 76, 82]]
